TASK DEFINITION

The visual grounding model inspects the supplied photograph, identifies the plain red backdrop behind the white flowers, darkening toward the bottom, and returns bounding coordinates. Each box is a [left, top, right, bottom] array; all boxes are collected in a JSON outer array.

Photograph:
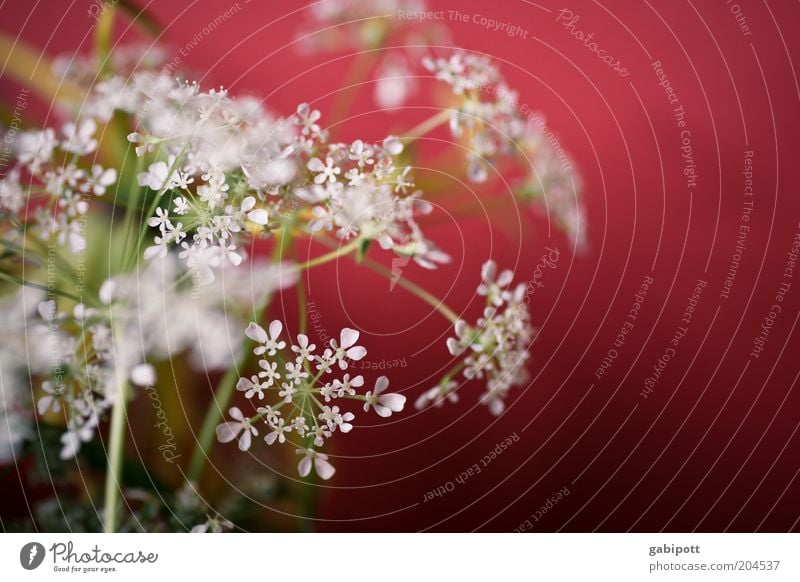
[[0, 0, 800, 531]]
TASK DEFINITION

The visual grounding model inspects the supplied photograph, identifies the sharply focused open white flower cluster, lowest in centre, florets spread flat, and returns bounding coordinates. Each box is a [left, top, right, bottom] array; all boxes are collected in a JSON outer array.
[[216, 320, 406, 479]]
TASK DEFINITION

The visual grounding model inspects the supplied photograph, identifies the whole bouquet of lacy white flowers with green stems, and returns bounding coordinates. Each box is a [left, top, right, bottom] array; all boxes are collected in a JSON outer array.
[[0, 0, 586, 531]]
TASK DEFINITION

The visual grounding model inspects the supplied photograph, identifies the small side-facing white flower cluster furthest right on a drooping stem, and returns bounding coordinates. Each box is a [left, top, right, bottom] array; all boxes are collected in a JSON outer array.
[[416, 260, 536, 415]]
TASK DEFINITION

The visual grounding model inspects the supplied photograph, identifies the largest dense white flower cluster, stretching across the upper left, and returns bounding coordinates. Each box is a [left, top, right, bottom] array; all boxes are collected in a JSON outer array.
[[40, 65, 449, 285]]
